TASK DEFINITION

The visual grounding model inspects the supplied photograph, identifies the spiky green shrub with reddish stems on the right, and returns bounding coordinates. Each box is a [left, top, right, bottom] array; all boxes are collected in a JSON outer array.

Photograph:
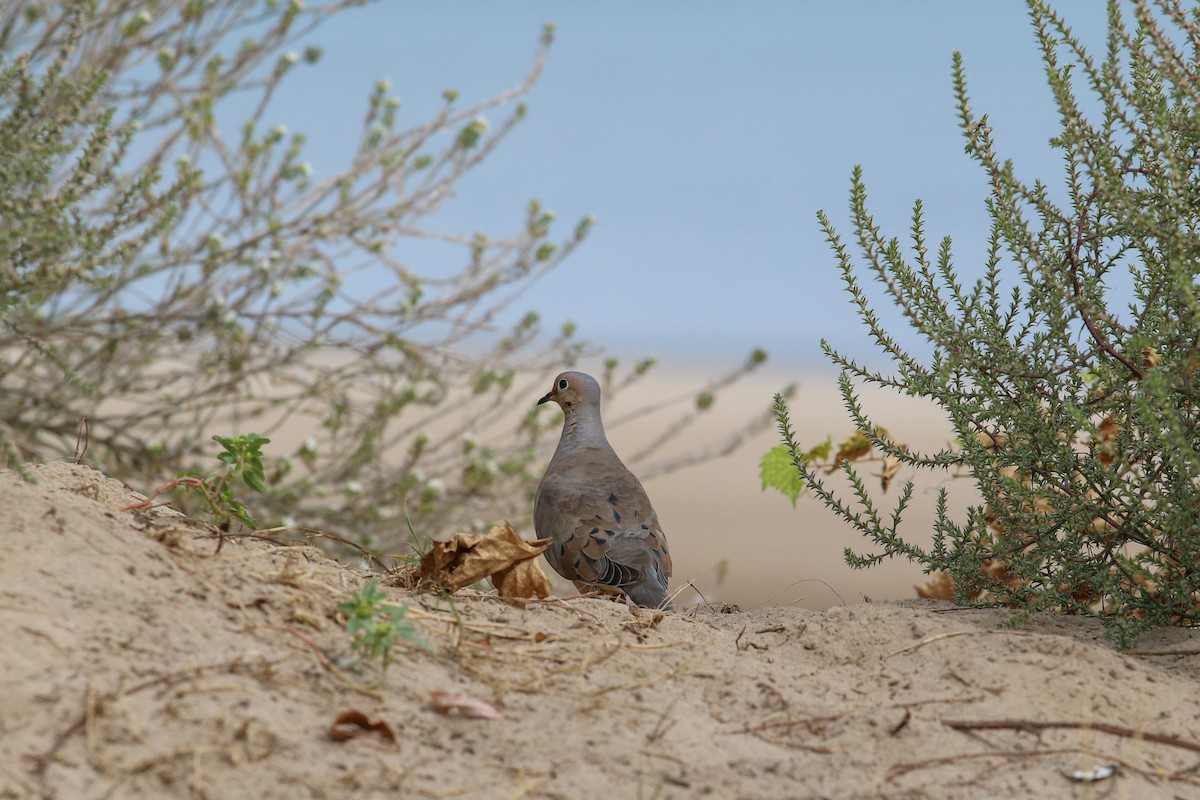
[[779, 0, 1200, 645]]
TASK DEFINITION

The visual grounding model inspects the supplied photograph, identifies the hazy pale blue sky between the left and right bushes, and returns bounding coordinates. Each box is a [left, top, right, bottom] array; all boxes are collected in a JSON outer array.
[[276, 0, 1105, 366]]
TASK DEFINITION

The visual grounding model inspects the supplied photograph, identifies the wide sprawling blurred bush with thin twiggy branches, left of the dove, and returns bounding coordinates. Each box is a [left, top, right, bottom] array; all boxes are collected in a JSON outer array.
[[0, 0, 761, 547]]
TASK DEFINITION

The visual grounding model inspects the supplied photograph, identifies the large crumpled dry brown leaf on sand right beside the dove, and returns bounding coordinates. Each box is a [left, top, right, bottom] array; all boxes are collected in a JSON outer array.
[[420, 522, 550, 599]]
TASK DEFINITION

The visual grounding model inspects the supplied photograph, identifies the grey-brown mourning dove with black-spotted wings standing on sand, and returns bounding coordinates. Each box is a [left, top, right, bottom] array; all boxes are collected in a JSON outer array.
[[533, 372, 671, 608]]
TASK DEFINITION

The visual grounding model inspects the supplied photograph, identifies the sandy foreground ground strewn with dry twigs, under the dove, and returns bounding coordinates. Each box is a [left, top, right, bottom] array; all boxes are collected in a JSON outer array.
[[0, 464, 1200, 800]]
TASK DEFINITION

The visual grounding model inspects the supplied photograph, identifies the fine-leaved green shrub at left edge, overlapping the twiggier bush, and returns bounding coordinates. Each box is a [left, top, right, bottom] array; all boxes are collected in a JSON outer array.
[[0, 2, 193, 465]]
